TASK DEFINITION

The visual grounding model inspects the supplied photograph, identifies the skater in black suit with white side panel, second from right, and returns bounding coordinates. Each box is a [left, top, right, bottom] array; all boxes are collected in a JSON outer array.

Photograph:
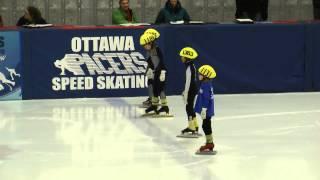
[[177, 47, 200, 138]]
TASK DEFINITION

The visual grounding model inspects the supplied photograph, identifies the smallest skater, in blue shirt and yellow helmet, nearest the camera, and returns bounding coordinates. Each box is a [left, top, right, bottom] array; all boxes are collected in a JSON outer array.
[[195, 65, 216, 154]]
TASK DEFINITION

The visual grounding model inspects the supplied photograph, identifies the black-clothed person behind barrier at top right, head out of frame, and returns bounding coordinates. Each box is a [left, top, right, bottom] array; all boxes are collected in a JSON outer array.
[[235, 0, 269, 21]]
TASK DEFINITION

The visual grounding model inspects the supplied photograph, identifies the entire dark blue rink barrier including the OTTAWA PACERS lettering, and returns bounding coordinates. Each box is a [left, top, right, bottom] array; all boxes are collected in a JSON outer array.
[[0, 24, 320, 99]]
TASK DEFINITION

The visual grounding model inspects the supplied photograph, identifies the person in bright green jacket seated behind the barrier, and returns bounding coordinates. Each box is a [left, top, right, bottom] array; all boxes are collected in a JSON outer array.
[[112, 0, 138, 25]]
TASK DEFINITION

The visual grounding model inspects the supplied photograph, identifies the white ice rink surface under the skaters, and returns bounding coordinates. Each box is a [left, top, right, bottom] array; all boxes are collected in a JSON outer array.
[[0, 93, 320, 180]]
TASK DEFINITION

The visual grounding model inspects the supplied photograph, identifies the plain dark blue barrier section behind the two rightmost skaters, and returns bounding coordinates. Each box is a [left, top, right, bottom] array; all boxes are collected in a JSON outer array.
[[166, 24, 305, 93]]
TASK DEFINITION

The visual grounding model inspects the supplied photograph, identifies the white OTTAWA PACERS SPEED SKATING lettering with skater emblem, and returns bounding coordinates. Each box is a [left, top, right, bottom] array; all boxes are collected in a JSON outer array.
[[52, 36, 147, 91]]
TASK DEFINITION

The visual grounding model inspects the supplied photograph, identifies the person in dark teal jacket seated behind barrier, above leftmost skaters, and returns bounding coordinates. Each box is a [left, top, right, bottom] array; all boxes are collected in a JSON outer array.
[[155, 0, 190, 24]]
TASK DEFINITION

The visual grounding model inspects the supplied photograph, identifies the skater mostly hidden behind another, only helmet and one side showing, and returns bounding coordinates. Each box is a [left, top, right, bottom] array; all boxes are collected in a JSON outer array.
[[142, 28, 160, 108]]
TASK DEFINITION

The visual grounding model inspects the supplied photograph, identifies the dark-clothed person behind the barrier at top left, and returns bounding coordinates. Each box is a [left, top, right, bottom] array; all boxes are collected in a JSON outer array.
[[17, 6, 47, 26]]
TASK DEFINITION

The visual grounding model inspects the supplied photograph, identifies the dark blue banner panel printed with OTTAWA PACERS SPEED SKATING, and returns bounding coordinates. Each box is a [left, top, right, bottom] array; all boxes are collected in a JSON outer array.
[[23, 28, 156, 99]]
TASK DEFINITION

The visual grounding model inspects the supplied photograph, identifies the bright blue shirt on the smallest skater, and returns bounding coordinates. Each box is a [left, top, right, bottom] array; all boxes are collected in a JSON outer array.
[[194, 81, 214, 118]]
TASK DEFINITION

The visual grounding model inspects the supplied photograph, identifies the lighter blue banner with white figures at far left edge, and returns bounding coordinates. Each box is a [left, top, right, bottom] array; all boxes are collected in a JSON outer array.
[[0, 31, 22, 100]]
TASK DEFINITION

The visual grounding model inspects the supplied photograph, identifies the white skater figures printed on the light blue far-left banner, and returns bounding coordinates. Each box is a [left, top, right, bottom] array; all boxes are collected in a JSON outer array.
[[0, 36, 21, 94]]
